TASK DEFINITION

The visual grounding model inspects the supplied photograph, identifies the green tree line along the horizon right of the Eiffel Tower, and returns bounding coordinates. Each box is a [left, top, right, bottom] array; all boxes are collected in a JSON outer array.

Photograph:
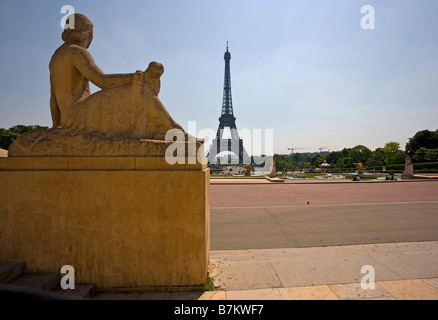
[[274, 129, 438, 171]]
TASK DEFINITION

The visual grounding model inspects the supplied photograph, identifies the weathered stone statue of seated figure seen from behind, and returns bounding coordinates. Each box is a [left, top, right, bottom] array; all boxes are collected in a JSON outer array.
[[9, 13, 199, 157]]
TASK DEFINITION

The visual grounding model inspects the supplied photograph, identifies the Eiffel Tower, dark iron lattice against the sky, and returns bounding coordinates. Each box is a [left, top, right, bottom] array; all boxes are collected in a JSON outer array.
[[208, 41, 251, 165]]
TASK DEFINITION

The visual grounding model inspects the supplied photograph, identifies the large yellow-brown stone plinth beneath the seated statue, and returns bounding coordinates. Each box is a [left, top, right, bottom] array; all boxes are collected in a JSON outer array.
[[0, 157, 210, 291]]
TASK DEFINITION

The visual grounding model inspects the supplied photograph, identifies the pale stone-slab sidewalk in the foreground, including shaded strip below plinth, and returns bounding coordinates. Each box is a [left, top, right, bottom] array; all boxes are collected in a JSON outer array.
[[95, 241, 438, 300]]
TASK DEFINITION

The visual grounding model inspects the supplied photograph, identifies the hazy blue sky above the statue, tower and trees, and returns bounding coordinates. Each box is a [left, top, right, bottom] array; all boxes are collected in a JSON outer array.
[[0, 0, 438, 153]]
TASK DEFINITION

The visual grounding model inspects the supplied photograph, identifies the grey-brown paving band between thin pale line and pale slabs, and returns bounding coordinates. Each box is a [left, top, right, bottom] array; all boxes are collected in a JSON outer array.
[[211, 201, 438, 250]]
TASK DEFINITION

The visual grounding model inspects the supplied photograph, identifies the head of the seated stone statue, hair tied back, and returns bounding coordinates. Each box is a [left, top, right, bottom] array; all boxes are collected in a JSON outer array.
[[62, 13, 93, 49]]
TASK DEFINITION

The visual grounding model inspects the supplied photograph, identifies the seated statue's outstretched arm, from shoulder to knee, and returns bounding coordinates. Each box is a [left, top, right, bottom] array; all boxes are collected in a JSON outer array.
[[73, 47, 133, 89]]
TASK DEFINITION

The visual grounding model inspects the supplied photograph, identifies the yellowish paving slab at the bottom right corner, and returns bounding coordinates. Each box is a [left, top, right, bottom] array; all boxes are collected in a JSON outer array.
[[377, 280, 438, 300]]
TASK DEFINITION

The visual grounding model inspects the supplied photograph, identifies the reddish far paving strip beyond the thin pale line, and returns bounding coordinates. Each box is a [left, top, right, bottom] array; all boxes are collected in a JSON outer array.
[[210, 179, 438, 208]]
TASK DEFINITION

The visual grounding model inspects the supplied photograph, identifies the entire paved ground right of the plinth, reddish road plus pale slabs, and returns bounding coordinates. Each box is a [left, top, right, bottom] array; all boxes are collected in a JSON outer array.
[[201, 180, 438, 300]]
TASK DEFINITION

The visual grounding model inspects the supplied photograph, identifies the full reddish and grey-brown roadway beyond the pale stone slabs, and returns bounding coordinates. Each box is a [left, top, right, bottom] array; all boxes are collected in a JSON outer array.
[[210, 181, 438, 250]]
